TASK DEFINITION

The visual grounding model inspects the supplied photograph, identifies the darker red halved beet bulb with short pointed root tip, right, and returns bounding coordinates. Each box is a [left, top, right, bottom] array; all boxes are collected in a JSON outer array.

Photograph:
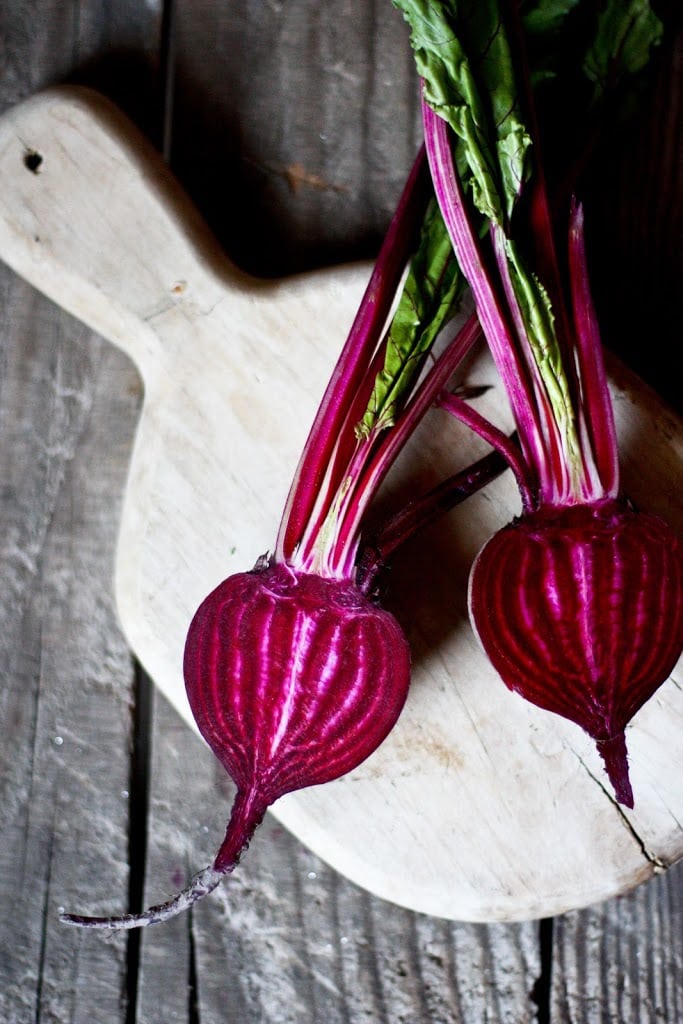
[[470, 500, 683, 807]]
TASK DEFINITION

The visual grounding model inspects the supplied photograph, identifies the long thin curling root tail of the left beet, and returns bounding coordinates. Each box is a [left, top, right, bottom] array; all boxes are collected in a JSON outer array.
[[59, 790, 267, 931]]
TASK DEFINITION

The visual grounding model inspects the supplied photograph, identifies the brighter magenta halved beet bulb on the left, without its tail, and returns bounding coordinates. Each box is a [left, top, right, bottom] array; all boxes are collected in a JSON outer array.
[[184, 564, 410, 835]]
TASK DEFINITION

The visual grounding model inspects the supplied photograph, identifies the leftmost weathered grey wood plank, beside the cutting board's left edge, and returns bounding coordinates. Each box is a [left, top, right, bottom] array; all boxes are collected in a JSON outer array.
[[0, 0, 159, 1024]]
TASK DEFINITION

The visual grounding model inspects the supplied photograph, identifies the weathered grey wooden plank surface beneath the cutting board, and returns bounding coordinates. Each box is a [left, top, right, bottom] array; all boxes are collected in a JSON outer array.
[[0, 0, 683, 1024]]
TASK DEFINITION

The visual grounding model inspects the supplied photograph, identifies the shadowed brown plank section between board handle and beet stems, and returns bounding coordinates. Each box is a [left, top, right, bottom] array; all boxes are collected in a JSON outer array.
[[171, 0, 419, 275]]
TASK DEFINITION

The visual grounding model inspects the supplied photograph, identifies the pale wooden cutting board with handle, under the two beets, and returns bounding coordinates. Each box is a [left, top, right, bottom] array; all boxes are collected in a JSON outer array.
[[0, 89, 683, 921]]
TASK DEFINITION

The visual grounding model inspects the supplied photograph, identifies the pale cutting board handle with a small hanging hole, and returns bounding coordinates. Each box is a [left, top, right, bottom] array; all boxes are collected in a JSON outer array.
[[0, 86, 254, 376]]
